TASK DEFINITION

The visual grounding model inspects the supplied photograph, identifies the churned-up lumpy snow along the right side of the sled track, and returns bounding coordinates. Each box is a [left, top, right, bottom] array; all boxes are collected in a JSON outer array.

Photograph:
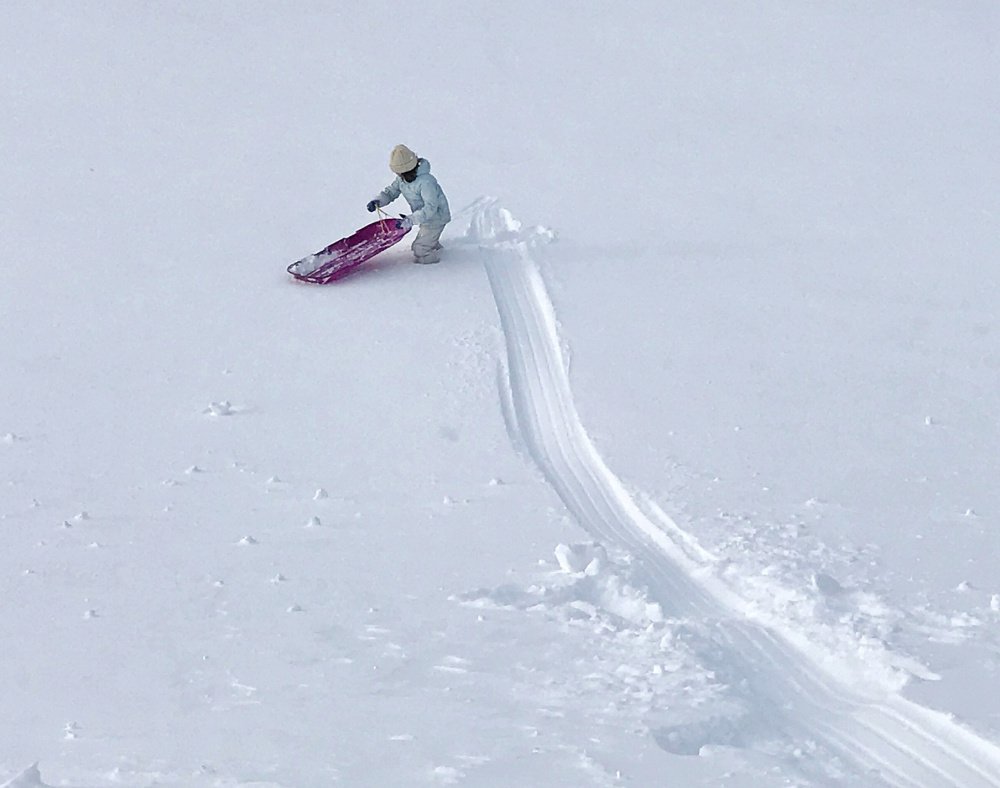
[[706, 499, 976, 690]]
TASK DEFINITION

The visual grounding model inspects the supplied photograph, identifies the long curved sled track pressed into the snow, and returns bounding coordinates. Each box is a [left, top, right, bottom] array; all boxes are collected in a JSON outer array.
[[467, 199, 1000, 788]]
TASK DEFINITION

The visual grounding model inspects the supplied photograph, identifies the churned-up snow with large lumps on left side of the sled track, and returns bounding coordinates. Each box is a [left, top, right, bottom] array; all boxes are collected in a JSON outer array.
[[459, 543, 768, 755]]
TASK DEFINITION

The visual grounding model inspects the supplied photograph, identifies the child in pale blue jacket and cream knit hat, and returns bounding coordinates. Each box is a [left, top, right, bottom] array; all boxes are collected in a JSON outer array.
[[367, 145, 451, 263]]
